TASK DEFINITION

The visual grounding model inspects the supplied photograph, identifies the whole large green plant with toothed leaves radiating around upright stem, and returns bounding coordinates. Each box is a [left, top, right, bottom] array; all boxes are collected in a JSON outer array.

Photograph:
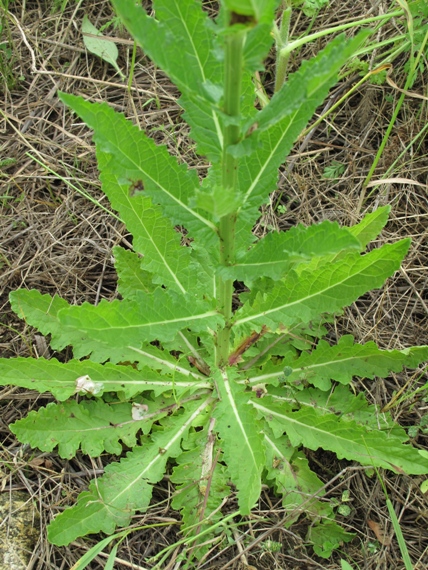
[[0, 0, 428, 557]]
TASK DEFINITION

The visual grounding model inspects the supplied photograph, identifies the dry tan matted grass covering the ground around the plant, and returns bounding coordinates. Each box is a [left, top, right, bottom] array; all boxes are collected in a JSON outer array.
[[0, 0, 428, 570]]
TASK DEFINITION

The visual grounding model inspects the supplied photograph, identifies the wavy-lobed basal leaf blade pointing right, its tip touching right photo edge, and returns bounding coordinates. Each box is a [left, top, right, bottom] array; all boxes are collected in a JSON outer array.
[[278, 335, 428, 390]]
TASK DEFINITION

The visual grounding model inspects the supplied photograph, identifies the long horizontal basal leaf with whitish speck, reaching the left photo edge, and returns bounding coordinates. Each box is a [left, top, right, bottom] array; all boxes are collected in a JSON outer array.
[[0, 356, 210, 401]]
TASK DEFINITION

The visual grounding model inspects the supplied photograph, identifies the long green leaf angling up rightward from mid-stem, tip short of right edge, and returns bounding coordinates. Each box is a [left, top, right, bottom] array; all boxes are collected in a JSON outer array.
[[234, 240, 410, 330]]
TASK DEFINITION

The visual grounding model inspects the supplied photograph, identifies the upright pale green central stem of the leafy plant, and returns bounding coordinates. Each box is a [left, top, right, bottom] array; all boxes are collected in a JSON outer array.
[[216, 31, 245, 366]]
